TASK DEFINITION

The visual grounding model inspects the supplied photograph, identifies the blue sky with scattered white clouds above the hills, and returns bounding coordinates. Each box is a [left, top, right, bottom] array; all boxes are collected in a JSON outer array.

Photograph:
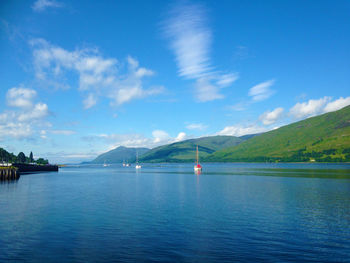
[[0, 0, 350, 163]]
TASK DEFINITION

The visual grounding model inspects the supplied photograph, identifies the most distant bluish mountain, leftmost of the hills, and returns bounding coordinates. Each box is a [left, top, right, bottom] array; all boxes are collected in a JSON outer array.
[[89, 146, 150, 163]]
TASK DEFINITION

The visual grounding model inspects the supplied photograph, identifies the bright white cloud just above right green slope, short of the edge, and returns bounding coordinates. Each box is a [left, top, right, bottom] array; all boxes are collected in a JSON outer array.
[[289, 97, 331, 119]]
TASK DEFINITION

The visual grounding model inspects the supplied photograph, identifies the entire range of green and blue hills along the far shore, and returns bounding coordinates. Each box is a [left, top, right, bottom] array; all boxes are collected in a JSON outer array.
[[90, 106, 350, 163]]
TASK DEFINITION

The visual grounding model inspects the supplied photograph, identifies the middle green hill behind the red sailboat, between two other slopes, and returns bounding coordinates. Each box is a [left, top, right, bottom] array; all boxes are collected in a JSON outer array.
[[140, 136, 244, 163]]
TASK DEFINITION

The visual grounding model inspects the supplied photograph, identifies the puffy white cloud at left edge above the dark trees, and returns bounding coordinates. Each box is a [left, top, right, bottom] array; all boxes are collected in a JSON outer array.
[[0, 86, 50, 140]]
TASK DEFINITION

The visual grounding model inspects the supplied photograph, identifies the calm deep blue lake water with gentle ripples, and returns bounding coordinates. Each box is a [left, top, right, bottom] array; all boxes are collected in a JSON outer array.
[[0, 164, 350, 262]]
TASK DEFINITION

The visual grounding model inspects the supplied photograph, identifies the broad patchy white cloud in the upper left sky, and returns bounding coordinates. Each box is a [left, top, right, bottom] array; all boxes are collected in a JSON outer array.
[[31, 39, 164, 109]]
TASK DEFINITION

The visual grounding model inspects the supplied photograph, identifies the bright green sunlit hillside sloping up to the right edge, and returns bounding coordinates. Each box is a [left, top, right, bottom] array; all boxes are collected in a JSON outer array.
[[205, 106, 350, 162]]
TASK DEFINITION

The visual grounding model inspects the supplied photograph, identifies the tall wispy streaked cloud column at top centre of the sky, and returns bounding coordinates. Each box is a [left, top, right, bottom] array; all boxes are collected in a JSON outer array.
[[164, 4, 238, 102]]
